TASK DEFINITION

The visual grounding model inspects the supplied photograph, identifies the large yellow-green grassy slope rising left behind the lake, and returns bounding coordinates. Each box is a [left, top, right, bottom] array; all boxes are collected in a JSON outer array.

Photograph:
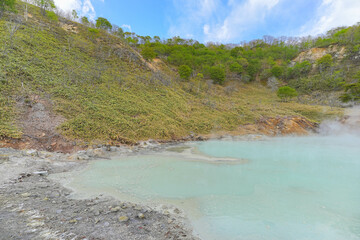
[[0, 3, 342, 142]]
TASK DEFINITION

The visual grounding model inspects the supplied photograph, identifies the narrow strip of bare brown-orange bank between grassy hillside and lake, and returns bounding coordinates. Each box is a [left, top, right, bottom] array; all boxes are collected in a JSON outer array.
[[0, 116, 319, 153]]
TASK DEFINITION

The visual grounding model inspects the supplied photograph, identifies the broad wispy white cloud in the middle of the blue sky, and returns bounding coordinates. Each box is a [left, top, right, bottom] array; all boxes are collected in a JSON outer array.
[[169, 0, 280, 42]]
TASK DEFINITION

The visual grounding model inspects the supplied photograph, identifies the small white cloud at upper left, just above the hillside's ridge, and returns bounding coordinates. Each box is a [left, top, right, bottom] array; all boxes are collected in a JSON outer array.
[[54, 0, 104, 19]]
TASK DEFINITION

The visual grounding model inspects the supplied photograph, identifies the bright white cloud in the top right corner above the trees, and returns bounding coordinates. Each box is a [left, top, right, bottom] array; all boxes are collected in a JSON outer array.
[[300, 0, 360, 35]]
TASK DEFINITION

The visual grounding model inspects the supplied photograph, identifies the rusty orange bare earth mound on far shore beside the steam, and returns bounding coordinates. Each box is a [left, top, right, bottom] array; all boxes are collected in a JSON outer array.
[[238, 117, 318, 136]]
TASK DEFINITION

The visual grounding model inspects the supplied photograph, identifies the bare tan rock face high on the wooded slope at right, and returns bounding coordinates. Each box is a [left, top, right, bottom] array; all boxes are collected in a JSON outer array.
[[292, 45, 346, 64]]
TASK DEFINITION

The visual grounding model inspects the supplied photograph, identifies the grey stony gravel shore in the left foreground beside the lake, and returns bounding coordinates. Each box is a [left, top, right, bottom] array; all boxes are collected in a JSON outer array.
[[0, 143, 198, 240]]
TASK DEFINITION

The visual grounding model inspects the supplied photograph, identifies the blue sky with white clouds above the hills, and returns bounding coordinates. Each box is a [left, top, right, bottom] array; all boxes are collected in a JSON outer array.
[[55, 0, 360, 44]]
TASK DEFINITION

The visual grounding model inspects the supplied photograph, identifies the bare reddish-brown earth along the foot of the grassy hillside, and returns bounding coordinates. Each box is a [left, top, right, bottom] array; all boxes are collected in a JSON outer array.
[[0, 113, 319, 153]]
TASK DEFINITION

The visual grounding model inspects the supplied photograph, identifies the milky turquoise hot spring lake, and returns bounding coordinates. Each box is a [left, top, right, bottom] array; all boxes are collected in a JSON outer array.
[[59, 135, 360, 240]]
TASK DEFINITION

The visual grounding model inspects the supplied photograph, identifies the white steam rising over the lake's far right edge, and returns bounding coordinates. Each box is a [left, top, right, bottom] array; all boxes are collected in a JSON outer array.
[[319, 107, 360, 137]]
